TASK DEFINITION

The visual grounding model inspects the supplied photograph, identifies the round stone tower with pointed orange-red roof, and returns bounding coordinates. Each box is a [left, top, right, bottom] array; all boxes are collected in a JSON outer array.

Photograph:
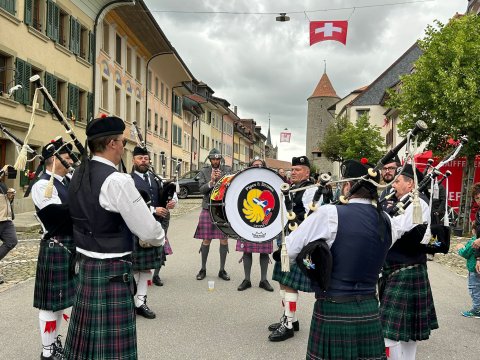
[[306, 71, 340, 173]]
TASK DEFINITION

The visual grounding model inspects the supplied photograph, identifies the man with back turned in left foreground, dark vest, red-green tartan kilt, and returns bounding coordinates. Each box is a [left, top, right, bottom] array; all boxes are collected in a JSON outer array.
[[65, 116, 165, 360]]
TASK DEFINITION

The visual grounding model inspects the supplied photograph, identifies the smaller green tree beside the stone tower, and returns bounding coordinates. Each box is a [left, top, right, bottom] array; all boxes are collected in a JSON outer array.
[[319, 114, 384, 163]]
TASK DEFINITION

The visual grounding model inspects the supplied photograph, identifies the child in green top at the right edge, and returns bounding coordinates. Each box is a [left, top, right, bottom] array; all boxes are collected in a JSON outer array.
[[456, 236, 480, 319]]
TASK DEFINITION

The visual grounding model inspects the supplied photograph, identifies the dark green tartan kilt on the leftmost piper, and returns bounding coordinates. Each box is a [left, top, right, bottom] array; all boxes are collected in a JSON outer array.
[[33, 236, 76, 311]]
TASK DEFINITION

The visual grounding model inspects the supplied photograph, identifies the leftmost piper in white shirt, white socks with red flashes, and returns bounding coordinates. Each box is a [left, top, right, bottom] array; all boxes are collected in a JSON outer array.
[[32, 141, 75, 360]]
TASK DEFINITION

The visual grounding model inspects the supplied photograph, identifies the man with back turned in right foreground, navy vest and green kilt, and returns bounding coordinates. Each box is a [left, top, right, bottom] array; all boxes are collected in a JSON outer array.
[[286, 160, 396, 360]]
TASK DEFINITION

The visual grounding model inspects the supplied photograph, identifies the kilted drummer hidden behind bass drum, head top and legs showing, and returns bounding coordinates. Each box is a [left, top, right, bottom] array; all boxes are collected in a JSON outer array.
[[236, 156, 273, 291]]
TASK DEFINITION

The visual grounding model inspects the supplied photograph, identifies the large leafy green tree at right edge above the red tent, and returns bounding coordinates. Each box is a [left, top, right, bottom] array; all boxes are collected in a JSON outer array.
[[387, 15, 480, 230]]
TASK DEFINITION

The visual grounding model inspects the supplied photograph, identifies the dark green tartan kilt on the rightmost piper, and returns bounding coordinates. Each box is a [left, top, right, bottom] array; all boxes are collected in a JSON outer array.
[[380, 264, 438, 341]]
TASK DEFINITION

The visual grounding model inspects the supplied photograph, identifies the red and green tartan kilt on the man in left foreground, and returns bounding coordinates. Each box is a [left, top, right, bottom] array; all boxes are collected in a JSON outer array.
[[65, 257, 137, 360]]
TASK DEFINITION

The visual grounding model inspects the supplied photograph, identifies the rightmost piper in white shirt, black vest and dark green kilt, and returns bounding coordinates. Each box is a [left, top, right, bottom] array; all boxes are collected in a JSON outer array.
[[380, 164, 438, 360]]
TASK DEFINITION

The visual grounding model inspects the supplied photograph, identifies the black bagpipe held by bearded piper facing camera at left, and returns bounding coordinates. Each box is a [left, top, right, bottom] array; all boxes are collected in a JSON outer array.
[[132, 121, 181, 208]]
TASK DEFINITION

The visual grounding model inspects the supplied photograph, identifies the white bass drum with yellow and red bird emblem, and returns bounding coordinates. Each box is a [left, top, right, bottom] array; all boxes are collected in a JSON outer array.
[[210, 167, 287, 243]]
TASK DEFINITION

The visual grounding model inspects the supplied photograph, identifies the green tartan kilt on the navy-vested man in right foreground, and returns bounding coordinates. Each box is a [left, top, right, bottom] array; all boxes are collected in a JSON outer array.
[[306, 299, 387, 360]]
